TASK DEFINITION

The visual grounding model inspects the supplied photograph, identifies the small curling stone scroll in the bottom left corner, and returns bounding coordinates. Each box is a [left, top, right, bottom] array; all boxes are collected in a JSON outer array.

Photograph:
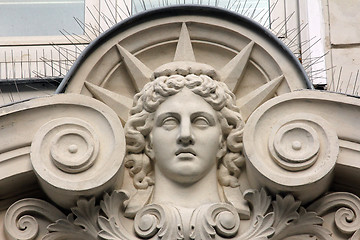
[[4, 198, 65, 240]]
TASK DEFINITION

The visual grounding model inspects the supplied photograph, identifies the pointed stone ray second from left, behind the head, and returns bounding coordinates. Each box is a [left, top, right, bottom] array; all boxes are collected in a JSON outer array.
[[116, 44, 153, 92]]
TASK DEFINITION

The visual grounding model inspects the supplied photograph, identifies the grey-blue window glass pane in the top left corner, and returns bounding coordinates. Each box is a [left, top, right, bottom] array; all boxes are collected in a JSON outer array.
[[0, 0, 85, 37]]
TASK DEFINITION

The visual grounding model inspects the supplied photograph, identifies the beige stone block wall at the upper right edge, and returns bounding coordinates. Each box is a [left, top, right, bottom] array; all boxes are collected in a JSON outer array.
[[322, 0, 360, 96]]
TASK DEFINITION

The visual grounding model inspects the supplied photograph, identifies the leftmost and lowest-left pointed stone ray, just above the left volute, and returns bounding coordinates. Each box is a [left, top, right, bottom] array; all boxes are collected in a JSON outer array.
[[85, 81, 132, 123]]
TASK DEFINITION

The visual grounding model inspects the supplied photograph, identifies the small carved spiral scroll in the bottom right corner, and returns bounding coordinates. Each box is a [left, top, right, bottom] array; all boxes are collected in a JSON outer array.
[[308, 192, 360, 234]]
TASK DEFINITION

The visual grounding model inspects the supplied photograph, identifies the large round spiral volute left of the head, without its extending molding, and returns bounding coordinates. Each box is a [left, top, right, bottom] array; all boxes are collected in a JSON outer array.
[[30, 94, 125, 208]]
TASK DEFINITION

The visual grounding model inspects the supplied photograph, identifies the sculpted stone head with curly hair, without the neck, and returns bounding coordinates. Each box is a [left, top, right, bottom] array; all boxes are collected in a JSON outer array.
[[125, 68, 244, 189]]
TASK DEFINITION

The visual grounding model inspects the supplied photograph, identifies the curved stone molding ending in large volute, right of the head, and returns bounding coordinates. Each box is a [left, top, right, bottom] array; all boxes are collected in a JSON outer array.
[[244, 90, 360, 202]]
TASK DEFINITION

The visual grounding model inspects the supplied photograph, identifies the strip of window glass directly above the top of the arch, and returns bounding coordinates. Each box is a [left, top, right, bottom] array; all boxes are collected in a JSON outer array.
[[132, 0, 270, 26]]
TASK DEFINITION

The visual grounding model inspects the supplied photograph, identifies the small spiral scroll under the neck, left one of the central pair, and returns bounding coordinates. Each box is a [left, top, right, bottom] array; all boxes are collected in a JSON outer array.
[[134, 204, 184, 240]]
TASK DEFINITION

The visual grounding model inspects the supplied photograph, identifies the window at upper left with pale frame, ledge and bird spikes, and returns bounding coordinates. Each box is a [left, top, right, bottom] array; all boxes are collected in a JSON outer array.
[[0, 0, 97, 105]]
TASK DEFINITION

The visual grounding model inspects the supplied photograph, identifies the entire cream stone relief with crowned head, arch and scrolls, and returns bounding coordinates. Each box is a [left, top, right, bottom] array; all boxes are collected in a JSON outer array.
[[0, 7, 360, 240]]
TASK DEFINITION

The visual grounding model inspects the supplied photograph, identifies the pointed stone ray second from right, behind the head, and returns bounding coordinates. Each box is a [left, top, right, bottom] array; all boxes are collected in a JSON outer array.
[[220, 41, 254, 92]]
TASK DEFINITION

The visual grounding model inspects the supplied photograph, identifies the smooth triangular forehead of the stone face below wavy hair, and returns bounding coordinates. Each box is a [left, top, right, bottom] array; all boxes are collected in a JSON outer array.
[[155, 87, 216, 118]]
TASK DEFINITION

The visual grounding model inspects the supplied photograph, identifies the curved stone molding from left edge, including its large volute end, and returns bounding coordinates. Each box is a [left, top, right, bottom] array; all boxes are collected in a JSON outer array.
[[0, 94, 125, 208]]
